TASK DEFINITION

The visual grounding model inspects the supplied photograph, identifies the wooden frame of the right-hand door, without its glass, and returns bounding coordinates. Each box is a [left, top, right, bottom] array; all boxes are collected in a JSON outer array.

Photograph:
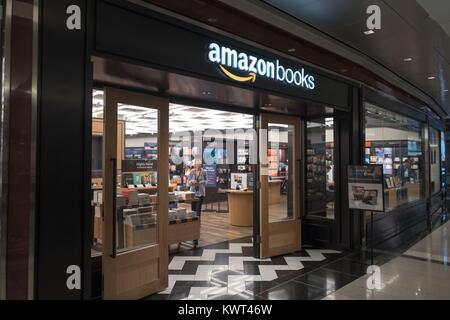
[[259, 113, 302, 258]]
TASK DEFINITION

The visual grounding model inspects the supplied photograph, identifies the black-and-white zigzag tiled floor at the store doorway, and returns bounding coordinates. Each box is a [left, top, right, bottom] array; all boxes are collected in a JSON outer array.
[[148, 237, 342, 300]]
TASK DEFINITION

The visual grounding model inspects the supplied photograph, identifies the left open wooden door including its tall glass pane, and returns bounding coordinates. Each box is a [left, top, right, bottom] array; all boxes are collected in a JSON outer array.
[[102, 88, 169, 299]]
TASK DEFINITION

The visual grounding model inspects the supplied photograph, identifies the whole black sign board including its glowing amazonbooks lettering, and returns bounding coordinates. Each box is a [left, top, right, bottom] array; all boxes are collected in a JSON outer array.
[[95, 0, 353, 112]]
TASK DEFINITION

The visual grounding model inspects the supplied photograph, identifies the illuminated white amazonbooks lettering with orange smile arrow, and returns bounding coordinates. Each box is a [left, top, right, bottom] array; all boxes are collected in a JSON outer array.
[[208, 42, 316, 90]]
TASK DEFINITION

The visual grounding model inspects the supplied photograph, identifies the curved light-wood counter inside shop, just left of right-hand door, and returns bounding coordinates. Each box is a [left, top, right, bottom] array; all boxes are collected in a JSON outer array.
[[225, 190, 253, 227]]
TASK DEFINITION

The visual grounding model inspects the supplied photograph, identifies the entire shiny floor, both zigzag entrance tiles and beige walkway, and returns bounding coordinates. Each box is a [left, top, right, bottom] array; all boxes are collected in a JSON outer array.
[[148, 215, 450, 300]]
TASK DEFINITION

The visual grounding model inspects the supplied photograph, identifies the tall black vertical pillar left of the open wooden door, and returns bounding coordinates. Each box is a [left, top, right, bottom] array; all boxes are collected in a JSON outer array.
[[36, 0, 91, 299]]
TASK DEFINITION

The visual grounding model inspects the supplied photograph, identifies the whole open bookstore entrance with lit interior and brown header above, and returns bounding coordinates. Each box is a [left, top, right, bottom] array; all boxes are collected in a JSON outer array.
[[89, 57, 348, 297]]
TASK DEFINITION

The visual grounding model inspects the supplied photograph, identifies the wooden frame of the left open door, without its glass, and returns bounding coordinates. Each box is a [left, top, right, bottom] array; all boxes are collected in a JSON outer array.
[[102, 87, 169, 299]]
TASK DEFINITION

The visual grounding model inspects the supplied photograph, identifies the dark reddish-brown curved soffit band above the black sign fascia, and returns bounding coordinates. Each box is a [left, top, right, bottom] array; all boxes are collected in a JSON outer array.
[[137, 0, 446, 117]]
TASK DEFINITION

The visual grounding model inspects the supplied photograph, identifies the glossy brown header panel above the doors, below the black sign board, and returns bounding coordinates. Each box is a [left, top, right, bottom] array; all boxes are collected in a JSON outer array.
[[92, 57, 316, 117]]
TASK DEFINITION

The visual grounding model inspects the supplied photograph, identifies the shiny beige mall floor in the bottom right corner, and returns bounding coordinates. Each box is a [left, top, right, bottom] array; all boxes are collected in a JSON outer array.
[[325, 222, 450, 300]]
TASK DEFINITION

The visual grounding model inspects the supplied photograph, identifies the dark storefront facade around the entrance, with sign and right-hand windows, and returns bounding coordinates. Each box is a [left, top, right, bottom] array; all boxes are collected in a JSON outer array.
[[0, 0, 445, 299]]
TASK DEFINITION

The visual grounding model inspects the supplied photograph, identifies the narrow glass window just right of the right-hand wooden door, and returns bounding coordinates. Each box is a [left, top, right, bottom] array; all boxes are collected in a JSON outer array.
[[306, 118, 335, 219]]
